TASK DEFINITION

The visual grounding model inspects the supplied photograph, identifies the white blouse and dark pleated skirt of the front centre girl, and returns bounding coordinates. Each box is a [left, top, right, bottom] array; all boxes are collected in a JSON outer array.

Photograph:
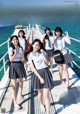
[[29, 52, 53, 89]]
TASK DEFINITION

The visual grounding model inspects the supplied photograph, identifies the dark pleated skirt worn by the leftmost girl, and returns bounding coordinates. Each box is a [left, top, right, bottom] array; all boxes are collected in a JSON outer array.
[[9, 61, 27, 79]]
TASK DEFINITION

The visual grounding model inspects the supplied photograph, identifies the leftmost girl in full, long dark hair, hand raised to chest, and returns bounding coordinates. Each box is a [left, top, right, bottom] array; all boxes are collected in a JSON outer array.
[[9, 35, 26, 108]]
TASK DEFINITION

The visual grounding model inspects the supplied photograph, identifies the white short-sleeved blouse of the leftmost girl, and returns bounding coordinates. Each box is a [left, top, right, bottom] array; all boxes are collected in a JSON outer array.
[[8, 47, 23, 61]]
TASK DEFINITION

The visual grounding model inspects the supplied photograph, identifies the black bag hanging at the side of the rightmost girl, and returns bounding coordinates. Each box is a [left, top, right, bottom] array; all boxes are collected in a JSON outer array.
[[53, 50, 64, 64]]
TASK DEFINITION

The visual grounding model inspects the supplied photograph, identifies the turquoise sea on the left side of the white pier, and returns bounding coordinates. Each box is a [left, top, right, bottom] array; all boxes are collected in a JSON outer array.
[[0, 26, 14, 80]]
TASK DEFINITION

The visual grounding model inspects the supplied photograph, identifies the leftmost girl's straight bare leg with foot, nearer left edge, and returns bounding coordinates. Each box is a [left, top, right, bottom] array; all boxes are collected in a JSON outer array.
[[11, 79, 19, 108]]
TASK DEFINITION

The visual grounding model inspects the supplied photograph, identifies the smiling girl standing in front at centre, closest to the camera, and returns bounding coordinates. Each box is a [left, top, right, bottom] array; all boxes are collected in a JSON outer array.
[[29, 39, 53, 114]]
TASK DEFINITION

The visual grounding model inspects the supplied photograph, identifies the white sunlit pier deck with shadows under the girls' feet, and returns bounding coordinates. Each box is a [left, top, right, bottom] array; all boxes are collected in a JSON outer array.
[[0, 26, 80, 114]]
